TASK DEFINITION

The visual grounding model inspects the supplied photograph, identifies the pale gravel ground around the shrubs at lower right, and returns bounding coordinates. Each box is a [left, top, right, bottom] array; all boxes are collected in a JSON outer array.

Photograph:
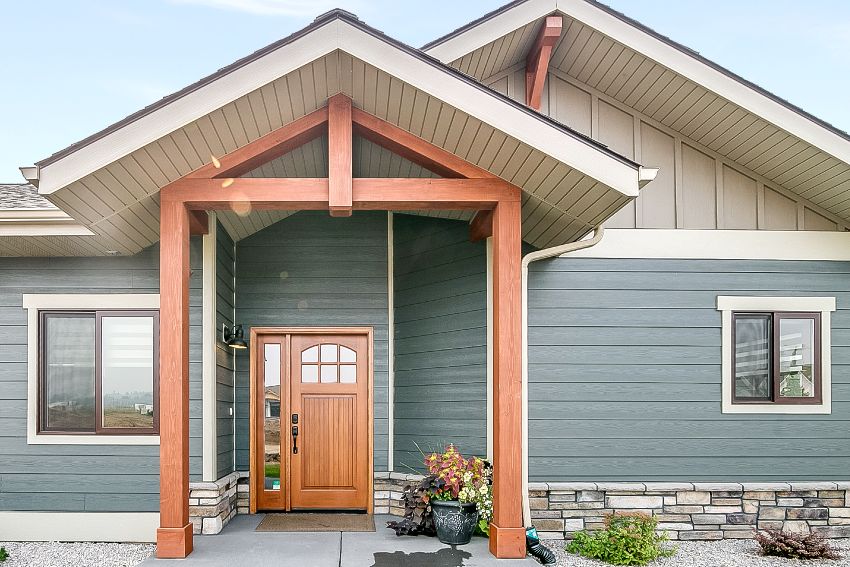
[[547, 539, 850, 567]]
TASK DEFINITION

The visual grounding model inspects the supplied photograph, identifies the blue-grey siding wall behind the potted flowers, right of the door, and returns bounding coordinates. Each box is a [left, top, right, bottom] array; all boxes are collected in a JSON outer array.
[[393, 214, 487, 472]]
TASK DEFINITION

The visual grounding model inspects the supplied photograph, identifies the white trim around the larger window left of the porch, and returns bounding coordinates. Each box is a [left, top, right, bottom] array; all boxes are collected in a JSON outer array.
[[23, 293, 159, 445]]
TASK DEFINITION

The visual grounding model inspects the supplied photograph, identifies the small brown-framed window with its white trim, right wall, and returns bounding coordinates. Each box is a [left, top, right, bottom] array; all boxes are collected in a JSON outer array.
[[717, 296, 835, 413]]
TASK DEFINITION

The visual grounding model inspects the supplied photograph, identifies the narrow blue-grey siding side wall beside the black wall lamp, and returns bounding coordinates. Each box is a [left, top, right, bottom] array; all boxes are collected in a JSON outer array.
[[215, 223, 236, 478]]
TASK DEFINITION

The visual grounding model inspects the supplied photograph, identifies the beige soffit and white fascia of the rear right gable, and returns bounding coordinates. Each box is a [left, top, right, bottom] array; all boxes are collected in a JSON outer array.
[[424, 0, 850, 226]]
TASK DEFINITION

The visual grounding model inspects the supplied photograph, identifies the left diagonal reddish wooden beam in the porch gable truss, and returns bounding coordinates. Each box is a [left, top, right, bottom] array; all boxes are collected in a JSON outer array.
[[186, 107, 328, 179]]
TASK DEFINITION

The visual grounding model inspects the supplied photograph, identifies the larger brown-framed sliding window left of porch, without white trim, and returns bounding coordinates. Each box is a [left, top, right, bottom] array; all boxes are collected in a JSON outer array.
[[38, 310, 159, 435]]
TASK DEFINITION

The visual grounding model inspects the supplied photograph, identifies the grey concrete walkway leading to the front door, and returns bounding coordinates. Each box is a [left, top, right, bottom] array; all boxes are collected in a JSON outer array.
[[142, 514, 539, 567]]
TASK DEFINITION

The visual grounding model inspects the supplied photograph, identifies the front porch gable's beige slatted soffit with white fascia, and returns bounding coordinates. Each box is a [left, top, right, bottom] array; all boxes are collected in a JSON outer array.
[[18, 10, 639, 254]]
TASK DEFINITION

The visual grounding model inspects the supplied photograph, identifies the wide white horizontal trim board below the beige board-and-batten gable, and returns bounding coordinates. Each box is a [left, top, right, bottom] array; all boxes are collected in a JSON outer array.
[[564, 228, 850, 261]]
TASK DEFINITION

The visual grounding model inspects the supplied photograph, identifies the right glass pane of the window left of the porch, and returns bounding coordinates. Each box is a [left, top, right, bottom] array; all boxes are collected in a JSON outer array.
[[101, 316, 156, 429]]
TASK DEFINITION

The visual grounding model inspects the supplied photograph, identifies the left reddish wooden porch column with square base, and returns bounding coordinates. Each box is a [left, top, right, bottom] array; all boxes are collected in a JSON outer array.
[[156, 199, 192, 559]]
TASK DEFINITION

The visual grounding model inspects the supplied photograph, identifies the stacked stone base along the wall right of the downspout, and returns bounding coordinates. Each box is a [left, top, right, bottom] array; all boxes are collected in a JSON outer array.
[[529, 482, 850, 540]]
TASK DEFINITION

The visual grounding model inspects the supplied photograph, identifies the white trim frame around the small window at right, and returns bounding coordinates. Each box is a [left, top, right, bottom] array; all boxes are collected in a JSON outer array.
[[717, 295, 835, 415]]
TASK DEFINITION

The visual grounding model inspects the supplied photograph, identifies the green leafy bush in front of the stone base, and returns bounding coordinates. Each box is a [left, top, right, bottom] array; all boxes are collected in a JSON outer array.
[[567, 514, 675, 565]]
